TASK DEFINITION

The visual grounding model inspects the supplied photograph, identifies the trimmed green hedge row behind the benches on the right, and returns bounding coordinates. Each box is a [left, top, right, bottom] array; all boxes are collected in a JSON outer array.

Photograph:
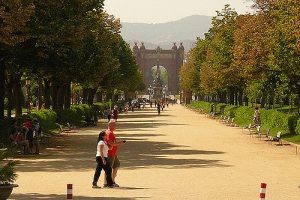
[[190, 101, 300, 134]]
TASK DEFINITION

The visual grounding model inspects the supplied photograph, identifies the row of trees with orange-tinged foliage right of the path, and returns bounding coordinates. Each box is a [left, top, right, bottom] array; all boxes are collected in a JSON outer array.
[[181, 0, 300, 107]]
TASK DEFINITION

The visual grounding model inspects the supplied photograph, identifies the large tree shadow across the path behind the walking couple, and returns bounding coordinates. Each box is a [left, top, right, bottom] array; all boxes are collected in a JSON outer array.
[[18, 108, 229, 172]]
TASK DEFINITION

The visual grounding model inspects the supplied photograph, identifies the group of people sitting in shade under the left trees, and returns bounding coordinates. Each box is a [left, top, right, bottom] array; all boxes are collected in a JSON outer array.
[[9, 118, 42, 154]]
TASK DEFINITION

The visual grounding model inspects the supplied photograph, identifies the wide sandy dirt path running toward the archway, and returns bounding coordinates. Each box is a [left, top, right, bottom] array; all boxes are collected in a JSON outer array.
[[12, 106, 300, 200]]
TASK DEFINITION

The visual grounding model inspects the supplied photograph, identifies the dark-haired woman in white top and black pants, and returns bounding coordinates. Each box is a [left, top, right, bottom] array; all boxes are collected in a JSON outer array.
[[93, 131, 113, 188]]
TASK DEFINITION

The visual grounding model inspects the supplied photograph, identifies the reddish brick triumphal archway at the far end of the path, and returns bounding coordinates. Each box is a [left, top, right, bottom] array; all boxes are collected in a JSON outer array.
[[133, 43, 184, 94]]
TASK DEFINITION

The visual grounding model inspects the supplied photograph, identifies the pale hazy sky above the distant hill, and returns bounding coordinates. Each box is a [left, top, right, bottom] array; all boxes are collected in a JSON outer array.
[[105, 0, 252, 23]]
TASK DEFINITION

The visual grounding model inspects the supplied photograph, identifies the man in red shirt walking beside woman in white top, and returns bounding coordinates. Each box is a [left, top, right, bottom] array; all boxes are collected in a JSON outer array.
[[105, 120, 126, 187]]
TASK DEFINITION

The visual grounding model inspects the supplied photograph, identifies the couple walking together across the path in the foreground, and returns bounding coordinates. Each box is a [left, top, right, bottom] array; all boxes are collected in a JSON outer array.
[[92, 119, 126, 188]]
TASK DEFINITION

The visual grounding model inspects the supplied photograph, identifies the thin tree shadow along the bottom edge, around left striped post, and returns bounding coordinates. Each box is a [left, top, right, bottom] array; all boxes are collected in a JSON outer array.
[[10, 193, 151, 200]]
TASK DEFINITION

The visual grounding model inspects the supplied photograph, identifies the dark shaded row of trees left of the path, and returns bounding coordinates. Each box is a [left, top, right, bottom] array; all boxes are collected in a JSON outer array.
[[0, 0, 143, 119]]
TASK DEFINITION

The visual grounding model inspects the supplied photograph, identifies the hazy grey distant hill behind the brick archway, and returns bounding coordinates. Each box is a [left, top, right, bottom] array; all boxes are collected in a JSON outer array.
[[121, 15, 212, 50]]
